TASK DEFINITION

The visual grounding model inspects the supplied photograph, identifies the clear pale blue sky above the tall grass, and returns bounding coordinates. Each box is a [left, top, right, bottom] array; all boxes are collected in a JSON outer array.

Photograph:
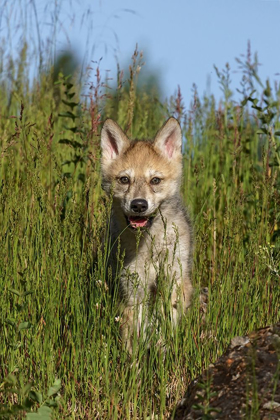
[[0, 0, 280, 104]]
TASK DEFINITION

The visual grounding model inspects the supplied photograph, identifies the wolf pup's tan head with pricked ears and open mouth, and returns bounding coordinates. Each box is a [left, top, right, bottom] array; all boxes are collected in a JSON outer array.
[[101, 118, 182, 229]]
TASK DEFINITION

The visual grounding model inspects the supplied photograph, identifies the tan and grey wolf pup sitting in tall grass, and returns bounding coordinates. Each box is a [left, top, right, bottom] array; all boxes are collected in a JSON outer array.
[[101, 118, 192, 352]]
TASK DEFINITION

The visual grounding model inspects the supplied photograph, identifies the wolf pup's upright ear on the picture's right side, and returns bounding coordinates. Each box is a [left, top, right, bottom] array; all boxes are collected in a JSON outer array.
[[154, 117, 182, 159]]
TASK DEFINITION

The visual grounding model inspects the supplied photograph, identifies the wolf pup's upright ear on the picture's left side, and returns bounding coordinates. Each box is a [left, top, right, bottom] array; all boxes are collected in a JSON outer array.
[[101, 119, 130, 160]]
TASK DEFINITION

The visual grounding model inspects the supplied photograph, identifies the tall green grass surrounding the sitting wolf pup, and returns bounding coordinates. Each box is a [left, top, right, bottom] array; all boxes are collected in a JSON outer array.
[[0, 47, 280, 419]]
